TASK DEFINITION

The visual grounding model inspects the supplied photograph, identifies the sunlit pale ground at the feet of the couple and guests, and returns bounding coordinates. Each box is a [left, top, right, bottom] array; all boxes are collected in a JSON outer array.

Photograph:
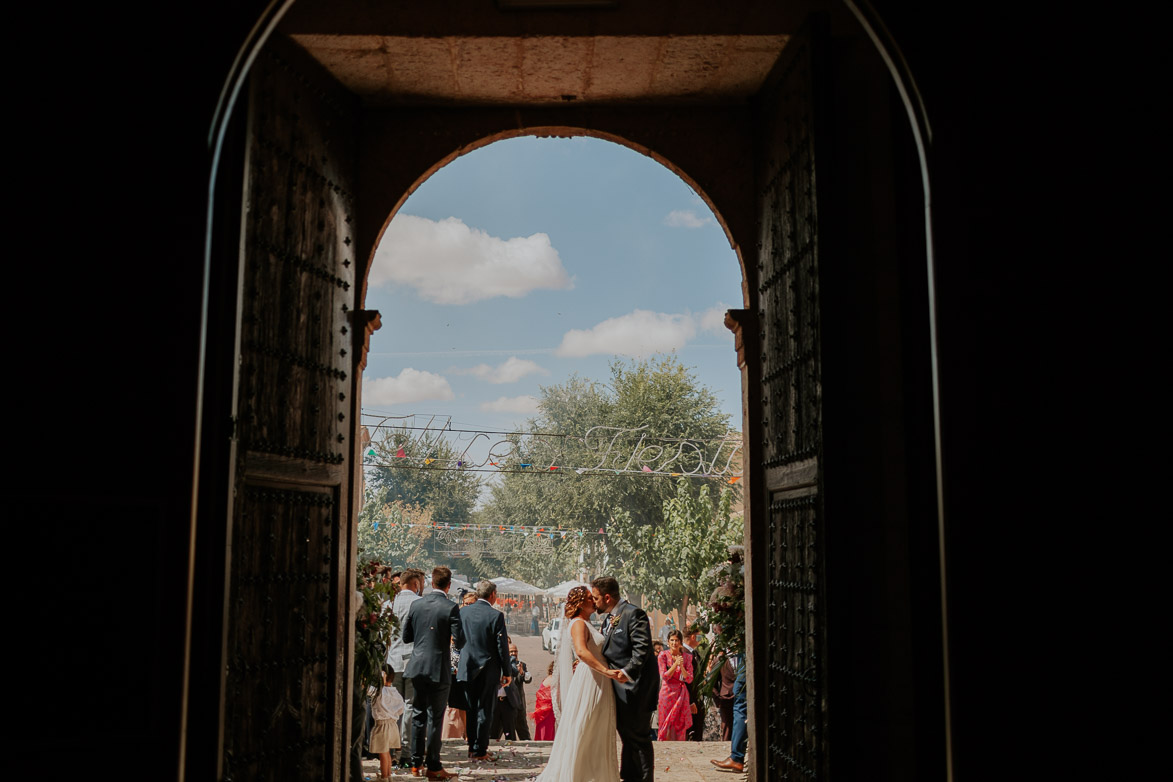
[[362, 739, 746, 782]]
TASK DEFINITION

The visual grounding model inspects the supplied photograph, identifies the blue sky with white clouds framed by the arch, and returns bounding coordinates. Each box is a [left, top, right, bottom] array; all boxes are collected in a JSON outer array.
[[362, 137, 741, 459]]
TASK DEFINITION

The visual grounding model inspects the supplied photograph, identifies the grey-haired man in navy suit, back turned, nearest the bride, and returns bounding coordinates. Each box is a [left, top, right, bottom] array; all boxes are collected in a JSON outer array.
[[456, 580, 511, 760]]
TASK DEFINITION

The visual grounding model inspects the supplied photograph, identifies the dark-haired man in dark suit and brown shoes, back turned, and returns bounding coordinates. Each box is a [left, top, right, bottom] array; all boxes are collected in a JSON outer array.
[[404, 565, 465, 780]]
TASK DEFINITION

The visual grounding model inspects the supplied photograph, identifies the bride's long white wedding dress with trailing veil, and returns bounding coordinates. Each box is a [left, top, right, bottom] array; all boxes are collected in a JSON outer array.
[[537, 617, 619, 782]]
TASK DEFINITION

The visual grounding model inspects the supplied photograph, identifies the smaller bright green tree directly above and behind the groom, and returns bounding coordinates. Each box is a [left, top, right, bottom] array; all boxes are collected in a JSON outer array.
[[608, 477, 744, 617]]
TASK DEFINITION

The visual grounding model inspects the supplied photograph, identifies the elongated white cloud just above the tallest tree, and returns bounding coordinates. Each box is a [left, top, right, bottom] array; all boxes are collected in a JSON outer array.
[[555, 310, 697, 358]]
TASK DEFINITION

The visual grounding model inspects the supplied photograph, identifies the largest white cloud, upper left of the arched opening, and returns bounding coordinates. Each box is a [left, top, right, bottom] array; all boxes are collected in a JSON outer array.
[[368, 215, 574, 304]]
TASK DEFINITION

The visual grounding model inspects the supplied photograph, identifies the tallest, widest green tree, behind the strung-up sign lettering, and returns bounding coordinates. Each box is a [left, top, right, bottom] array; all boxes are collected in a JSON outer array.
[[475, 358, 738, 589]]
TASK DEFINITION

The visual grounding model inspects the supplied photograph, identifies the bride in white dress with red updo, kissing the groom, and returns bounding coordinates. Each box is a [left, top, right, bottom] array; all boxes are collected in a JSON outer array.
[[537, 586, 619, 782]]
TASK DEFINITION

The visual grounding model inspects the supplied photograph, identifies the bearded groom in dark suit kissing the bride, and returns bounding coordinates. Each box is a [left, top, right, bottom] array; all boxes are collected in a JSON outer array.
[[590, 576, 659, 782]]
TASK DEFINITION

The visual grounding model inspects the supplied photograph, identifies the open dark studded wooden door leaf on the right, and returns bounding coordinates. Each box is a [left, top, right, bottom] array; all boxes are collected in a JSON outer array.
[[750, 29, 827, 780]]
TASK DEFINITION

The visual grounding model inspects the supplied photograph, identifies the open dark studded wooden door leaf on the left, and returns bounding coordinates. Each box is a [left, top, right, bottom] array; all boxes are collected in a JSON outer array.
[[221, 41, 355, 781]]
